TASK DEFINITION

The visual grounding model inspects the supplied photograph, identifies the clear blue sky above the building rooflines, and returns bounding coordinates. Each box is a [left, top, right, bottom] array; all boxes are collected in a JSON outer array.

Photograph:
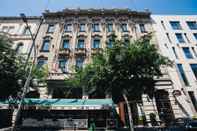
[[0, 0, 197, 16]]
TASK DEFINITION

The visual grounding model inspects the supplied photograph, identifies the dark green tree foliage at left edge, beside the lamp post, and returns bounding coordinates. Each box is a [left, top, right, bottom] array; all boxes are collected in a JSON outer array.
[[0, 36, 47, 99]]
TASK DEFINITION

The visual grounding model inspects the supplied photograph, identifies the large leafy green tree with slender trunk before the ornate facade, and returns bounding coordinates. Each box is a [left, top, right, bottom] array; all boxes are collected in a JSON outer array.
[[64, 34, 172, 130]]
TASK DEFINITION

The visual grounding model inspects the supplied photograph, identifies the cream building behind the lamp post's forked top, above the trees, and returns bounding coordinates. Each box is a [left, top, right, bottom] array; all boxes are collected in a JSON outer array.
[[0, 17, 40, 55]]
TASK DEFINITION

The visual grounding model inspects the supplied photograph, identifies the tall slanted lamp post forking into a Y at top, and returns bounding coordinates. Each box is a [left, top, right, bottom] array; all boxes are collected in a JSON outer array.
[[13, 13, 43, 130]]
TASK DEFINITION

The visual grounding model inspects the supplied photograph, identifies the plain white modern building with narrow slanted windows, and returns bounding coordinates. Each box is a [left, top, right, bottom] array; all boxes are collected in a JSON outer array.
[[152, 15, 197, 117]]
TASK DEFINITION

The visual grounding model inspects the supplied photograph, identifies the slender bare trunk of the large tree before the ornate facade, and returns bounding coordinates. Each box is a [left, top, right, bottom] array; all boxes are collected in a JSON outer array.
[[123, 93, 134, 131]]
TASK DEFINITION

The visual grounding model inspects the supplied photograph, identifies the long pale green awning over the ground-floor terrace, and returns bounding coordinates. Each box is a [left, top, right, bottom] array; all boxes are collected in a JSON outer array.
[[0, 98, 114, 110]]
